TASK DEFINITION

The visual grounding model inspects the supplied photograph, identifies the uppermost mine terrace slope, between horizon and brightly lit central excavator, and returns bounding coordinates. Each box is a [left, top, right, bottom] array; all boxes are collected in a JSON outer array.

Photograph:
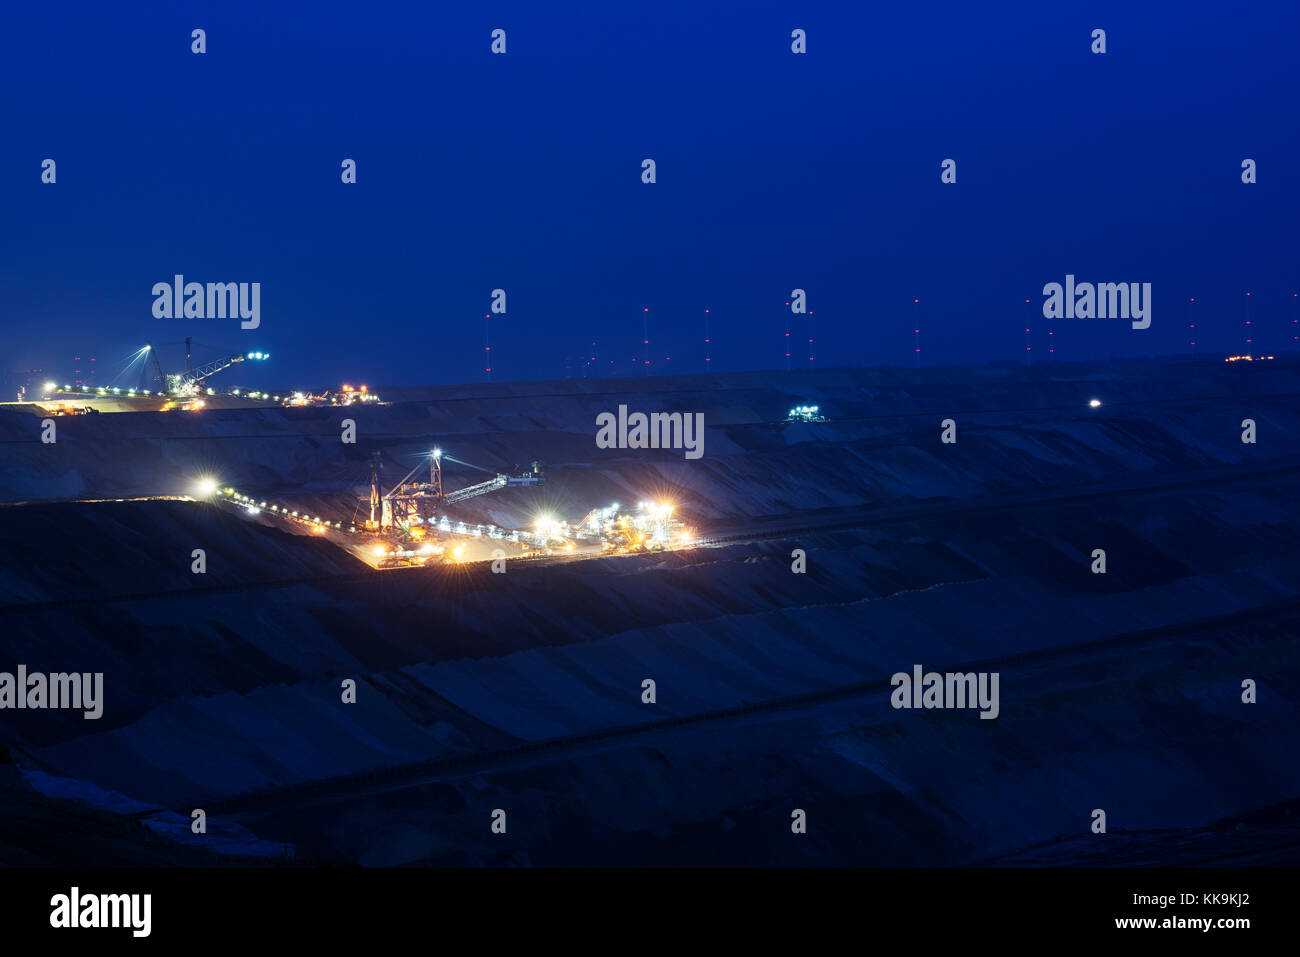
[[0, 363, 1300, 524]]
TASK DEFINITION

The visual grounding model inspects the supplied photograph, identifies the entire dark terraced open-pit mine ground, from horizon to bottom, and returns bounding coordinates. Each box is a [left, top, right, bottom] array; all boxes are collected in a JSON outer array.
[[0, 364, 1300, 866]]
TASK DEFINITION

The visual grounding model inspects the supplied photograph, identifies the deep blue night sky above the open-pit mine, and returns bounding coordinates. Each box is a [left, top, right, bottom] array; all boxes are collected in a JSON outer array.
[[0, 0, 1300, 398]]
